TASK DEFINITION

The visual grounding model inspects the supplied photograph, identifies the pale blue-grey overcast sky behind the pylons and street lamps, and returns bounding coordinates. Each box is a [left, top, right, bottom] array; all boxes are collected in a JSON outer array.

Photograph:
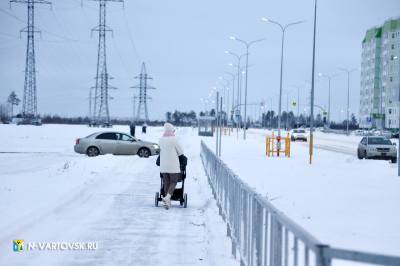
[[0, 0, 400, 119]]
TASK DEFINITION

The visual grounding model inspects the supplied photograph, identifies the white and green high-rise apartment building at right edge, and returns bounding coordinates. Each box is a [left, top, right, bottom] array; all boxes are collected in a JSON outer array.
[[360, 18, 400, 128]]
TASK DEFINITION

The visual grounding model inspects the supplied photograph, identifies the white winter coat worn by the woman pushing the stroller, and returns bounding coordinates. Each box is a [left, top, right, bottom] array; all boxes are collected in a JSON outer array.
[[158, 136, 183, 174]]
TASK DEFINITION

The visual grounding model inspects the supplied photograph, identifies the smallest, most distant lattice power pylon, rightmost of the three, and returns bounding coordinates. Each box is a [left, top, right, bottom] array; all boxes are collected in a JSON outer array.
[[131, 62, 156, 123]]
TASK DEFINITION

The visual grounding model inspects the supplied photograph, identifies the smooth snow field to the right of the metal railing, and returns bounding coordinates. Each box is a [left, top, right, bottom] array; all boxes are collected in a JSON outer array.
[[205, 130, 400, 255]]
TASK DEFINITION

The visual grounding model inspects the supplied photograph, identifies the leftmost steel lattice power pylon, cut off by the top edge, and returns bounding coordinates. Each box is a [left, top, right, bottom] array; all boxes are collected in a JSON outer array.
[[10, 0, 51, 119]]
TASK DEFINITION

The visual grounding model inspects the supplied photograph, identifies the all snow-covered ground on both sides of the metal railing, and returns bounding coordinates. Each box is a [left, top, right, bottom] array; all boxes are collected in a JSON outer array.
[[0, 125, 400, 265]]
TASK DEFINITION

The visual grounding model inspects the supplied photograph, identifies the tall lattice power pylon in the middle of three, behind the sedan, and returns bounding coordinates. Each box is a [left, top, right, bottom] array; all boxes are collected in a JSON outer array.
[[91, 0, 123, 127]]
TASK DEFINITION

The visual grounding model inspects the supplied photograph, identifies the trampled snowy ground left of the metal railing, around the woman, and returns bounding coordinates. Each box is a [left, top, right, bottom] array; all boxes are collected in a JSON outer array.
[[0, 125, 238, 265]]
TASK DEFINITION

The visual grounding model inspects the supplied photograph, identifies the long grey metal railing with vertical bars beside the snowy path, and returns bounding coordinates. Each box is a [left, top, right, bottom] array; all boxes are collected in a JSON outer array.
[[201, 142, 400, 266]]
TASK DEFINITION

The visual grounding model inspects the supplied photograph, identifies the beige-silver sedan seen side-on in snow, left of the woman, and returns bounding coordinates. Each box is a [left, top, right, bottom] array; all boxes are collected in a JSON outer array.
[[74, 132, 160, 158]]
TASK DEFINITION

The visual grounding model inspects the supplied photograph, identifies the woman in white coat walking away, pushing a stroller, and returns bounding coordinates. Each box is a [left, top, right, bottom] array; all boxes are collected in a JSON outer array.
[[159, 123, 183, 209]]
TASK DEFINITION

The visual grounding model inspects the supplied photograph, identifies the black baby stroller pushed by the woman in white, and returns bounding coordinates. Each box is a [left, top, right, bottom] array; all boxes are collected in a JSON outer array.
[[154, 155, 187, 208]]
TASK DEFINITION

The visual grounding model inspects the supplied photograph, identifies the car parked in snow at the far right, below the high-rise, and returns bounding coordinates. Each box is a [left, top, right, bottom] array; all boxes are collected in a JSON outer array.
[[357, 136, 397, 163]]
